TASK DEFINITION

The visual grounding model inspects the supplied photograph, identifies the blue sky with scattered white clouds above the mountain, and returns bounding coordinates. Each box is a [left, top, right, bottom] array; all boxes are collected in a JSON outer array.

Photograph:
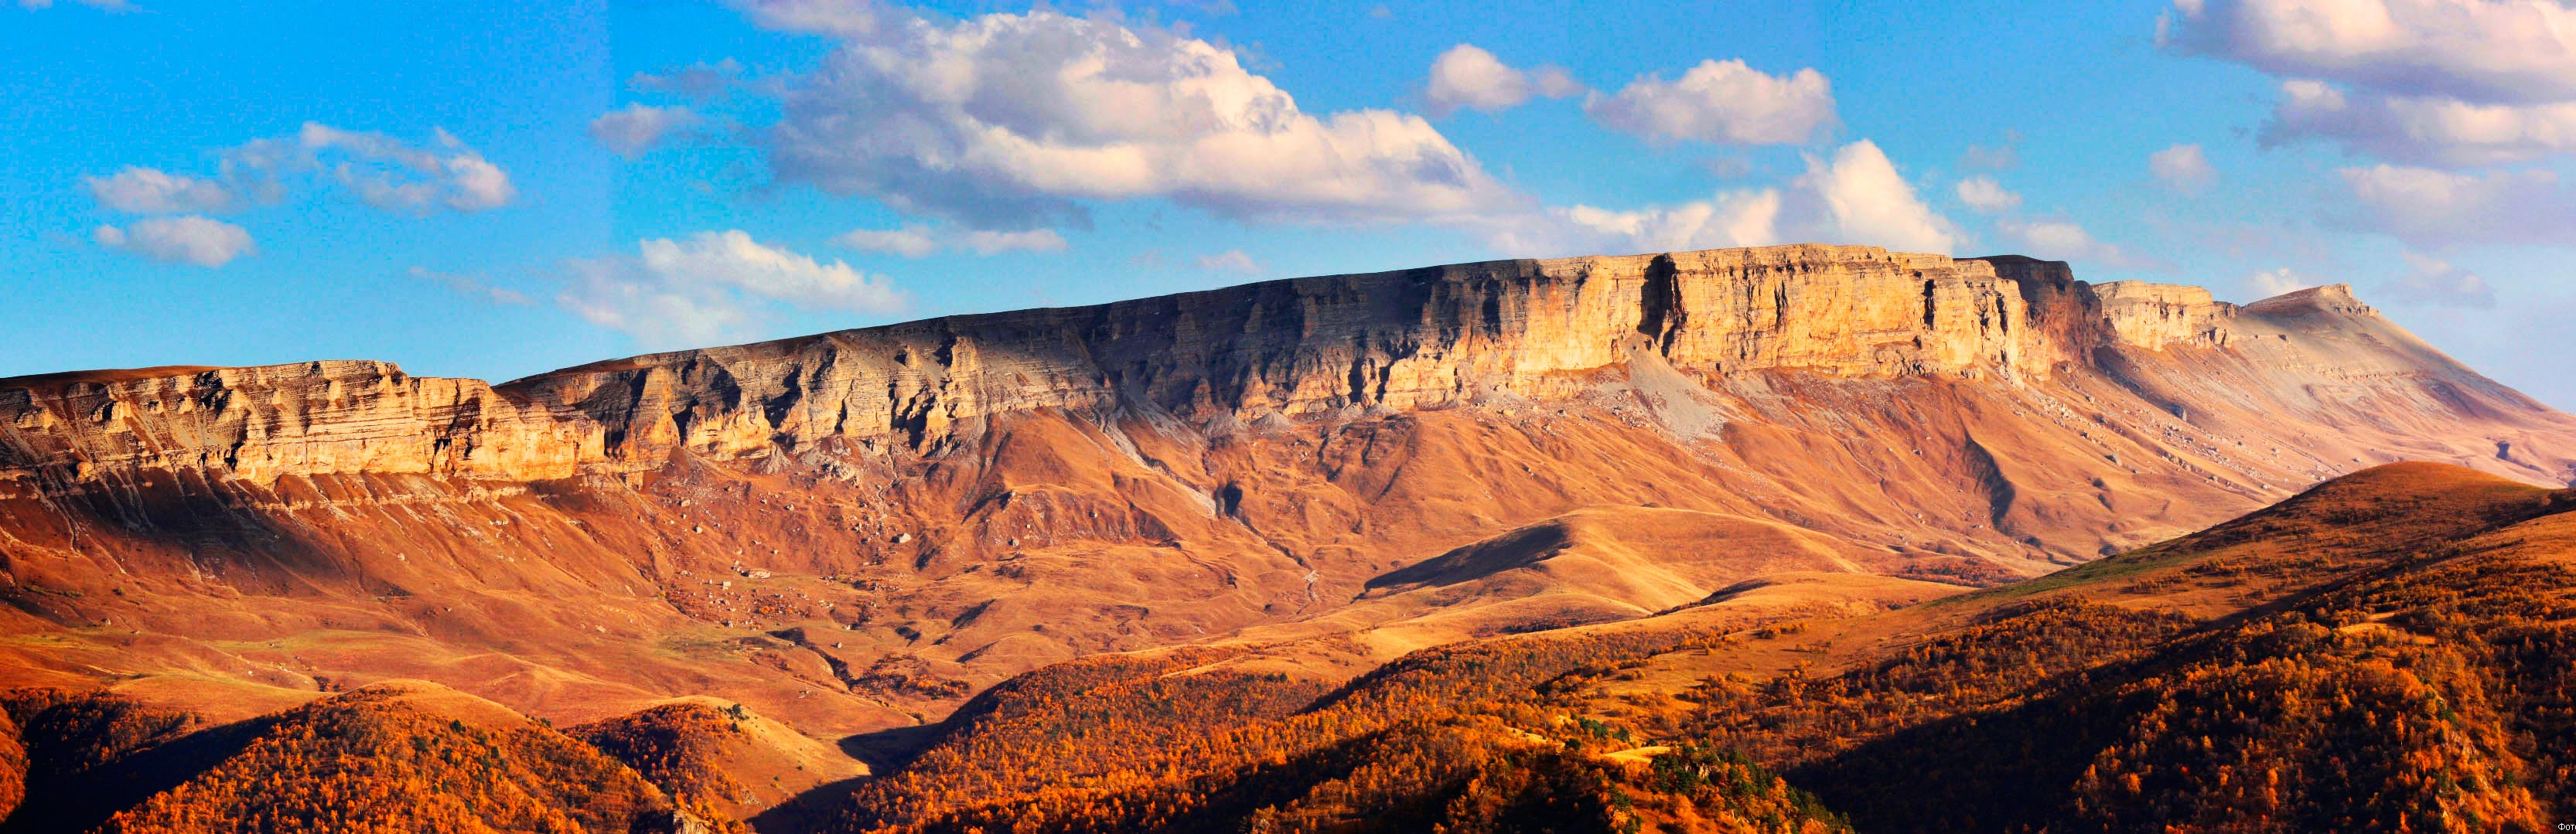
[[0, 0, 2576, 410]]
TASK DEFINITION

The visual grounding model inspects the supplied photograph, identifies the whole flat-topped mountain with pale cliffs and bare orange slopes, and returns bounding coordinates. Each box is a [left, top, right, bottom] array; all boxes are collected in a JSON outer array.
[[0, 244, 2576, 829]]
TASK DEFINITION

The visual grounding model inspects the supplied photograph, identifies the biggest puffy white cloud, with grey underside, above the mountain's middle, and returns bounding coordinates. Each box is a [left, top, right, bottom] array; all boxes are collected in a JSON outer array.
[[752, 2, 1517, 229]]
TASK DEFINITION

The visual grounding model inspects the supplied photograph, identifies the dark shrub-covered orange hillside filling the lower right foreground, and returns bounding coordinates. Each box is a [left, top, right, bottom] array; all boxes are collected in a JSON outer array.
[[804, 463, 2576, 832]]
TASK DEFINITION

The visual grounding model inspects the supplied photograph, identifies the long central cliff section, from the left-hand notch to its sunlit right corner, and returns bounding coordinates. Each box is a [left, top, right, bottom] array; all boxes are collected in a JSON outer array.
[[505, 247, 2032, 463]]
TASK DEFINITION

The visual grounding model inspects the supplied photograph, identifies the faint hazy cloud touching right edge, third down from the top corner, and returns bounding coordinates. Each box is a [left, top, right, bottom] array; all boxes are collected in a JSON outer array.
[[2326, 165, 2576, 247]]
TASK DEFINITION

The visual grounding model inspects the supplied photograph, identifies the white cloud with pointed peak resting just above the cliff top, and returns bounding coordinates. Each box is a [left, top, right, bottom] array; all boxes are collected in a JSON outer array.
[[1486, 139, 1960, 255]]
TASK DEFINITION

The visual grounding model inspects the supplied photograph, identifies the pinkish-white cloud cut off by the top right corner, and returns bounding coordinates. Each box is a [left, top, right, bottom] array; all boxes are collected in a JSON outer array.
[[2156, 0, 2576, 103]]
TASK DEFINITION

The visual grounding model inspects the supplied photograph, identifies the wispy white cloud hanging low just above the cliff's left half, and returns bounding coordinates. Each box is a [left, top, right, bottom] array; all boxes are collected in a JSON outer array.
[[556, 232, 909, 350]]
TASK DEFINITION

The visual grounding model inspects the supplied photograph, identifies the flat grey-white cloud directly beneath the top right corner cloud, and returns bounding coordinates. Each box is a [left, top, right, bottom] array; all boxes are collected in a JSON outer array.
[[2262, 80, 2576, 165]]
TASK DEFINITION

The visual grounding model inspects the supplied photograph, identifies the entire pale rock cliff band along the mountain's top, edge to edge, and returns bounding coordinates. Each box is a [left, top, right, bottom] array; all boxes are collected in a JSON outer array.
[[0, 244, 2565, 489]]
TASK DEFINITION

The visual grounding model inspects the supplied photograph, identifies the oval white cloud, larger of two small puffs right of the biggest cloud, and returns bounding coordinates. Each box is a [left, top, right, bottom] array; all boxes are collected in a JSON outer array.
[[1585, 60, 1834, 144]]
